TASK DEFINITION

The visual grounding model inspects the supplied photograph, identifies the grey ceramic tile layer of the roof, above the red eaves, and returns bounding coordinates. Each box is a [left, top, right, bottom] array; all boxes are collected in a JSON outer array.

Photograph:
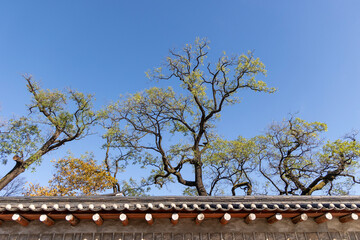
[[0, 196, 360, 213]]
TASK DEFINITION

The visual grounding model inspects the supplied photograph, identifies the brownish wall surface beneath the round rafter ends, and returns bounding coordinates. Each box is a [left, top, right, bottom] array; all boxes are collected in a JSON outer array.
[[0, 218, 360, 240]]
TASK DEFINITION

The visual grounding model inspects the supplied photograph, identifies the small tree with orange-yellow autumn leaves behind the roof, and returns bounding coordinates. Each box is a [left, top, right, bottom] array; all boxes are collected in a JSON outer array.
[[26, 155, 117, 196]]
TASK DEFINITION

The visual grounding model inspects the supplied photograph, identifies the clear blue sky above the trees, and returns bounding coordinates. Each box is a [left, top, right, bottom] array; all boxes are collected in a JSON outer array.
[[0, 0, 360, 194]]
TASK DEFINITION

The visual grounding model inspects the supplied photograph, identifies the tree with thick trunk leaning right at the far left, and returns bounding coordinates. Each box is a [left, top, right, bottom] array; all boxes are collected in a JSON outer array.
[[0, 76, 97, 190]]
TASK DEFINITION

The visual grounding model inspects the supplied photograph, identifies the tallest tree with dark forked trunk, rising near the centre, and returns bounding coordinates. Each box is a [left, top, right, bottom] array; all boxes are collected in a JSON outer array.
[[103, 39, 275, 195]]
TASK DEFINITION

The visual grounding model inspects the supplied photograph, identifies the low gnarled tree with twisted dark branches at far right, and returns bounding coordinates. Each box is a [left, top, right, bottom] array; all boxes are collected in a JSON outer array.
[[257, 117, 360, 195]]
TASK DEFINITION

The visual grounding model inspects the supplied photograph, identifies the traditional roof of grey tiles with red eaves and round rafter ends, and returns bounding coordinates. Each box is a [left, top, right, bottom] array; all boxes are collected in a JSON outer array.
[[0, 195, 360, 229]]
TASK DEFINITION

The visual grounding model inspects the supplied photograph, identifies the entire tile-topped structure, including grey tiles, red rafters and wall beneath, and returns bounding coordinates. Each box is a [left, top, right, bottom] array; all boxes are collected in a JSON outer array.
[[0, 195, 360, 240]]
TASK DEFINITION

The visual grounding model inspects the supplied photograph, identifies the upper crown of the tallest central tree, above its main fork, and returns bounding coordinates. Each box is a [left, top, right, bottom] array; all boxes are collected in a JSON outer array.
[[146, 38, 276, 116]]
